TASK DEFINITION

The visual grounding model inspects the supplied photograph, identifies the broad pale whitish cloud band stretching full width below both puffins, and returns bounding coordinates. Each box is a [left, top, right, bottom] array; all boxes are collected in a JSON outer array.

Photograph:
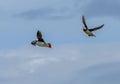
[[0, 45, 119, 77]]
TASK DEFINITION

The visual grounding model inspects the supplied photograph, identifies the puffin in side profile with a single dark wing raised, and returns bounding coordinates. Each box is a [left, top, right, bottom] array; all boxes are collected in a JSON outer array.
[[31, 30, 52, 48]]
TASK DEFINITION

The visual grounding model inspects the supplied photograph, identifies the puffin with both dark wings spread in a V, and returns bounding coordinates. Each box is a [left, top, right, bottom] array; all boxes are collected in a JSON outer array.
[[82, 16, 104, 37]]
